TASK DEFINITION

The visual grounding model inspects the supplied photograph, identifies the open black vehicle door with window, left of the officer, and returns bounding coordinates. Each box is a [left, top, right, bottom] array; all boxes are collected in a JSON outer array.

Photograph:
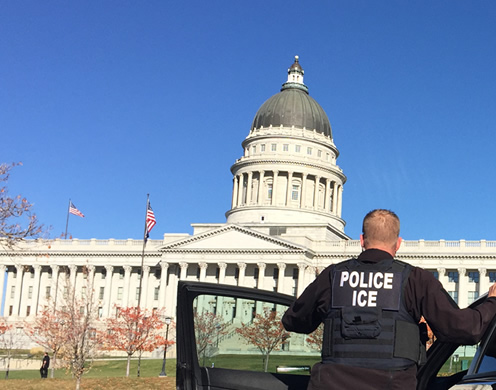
[[176, 281, 320, 390]]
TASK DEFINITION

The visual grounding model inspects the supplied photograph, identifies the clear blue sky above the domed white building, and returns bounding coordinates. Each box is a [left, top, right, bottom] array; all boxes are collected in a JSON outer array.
[[0, 0, 496, 240]]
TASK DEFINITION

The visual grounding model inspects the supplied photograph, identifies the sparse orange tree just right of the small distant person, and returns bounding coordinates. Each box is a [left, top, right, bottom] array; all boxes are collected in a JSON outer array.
[[24, 306, 67, 378]]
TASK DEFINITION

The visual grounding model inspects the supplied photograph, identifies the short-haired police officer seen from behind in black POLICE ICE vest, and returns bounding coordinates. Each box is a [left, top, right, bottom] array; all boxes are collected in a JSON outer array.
[[282, 209, 496, 390]]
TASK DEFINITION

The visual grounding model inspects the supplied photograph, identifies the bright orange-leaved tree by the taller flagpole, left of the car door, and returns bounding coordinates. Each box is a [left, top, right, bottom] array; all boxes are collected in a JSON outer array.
[[103, 307, 172, 377]]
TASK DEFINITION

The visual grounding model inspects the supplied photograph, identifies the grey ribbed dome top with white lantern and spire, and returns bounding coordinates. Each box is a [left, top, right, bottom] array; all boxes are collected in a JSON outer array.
[[251, 56, 332, 138]]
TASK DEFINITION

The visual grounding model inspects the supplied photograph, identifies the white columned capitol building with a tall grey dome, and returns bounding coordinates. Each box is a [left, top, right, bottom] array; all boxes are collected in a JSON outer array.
[[0, 57, 496, 348]]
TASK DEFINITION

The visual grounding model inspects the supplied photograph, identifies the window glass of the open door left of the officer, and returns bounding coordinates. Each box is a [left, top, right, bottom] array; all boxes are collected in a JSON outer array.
[[193, 295, 323, 375]]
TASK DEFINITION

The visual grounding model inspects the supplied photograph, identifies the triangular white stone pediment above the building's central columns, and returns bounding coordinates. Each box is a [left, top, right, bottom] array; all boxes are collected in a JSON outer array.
[[159, 225, 304, 251]]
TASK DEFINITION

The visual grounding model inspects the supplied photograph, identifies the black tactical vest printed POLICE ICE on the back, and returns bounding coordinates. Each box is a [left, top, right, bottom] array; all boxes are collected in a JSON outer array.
[[322, 259, 425, 370]]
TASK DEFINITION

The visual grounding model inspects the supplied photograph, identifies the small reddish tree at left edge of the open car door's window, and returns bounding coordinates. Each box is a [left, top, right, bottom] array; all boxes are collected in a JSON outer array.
[[195, 311, 227, 365]]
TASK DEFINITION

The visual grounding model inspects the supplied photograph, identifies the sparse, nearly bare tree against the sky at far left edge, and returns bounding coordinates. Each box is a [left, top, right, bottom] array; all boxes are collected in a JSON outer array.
[[0, 163, 44, 249]]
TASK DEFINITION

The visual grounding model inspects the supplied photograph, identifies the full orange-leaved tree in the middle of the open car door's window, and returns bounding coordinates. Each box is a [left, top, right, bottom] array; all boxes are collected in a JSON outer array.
[[236, 308, 290, 372]]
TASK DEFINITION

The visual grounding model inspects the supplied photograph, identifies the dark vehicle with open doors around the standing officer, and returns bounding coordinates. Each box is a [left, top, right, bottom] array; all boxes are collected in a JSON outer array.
[[176, 281, 496, 390]]
